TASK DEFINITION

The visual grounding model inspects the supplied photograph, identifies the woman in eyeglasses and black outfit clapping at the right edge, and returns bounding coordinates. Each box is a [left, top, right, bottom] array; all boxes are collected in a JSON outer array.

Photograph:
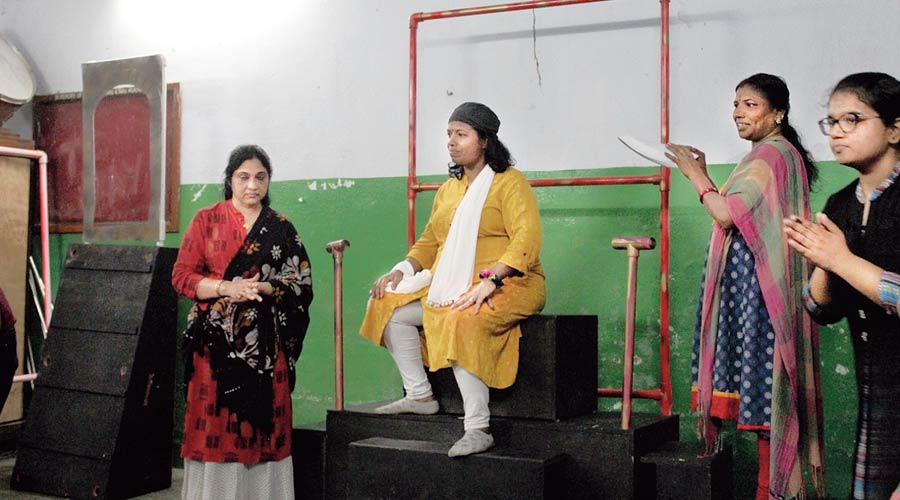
[[784, 73, 900, 500]]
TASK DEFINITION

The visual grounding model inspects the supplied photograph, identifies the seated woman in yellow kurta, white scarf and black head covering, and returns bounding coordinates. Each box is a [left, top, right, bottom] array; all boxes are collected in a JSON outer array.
[[360, 103, 546, 457]]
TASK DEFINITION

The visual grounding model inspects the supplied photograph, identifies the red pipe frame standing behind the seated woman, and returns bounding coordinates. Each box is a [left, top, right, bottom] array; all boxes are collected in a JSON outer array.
[[406, 0, 672, 415]]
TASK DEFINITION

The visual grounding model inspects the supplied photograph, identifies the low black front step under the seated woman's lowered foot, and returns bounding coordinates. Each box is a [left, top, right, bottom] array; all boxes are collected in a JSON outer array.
[[347, 437, 566, 500]]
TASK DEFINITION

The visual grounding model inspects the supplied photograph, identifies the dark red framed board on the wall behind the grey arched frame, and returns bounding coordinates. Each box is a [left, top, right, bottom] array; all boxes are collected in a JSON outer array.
[[34, 83, 181, 232]]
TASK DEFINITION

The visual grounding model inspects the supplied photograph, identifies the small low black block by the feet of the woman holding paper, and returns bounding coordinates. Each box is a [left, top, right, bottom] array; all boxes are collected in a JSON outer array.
[[641, 442, 734, 500]]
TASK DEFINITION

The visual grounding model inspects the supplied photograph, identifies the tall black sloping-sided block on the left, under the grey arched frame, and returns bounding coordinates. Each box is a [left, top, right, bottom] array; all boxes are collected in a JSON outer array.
[[11, 245, 178, 500]]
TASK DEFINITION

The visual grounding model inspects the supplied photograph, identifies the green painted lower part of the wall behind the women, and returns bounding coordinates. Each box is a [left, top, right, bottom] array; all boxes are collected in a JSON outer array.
[[40, 163, 856, 497]]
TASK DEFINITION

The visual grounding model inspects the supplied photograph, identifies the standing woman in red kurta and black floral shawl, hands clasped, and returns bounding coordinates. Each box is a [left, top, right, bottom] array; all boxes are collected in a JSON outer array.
[[172, 146, 313, 500]]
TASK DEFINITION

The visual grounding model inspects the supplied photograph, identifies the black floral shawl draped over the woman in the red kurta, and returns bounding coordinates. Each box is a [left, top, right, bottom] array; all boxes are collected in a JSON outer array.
[[184, 207, 313, 434]]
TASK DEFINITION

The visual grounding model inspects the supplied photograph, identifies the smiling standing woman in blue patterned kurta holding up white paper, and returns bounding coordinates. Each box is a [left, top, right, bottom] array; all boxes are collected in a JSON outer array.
[[668, 73, 824, 500]]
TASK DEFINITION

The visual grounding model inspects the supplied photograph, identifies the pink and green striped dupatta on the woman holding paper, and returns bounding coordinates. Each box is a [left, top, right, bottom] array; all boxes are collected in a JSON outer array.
[[698, 138, 825, 499]]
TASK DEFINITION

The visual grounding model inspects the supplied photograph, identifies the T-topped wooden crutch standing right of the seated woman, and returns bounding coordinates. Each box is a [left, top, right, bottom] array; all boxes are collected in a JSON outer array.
[[612, 236, 656, 430]]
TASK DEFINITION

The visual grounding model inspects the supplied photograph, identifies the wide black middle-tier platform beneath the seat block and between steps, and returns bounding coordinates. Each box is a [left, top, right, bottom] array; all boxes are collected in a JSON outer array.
[[325, 402, 678, 499]]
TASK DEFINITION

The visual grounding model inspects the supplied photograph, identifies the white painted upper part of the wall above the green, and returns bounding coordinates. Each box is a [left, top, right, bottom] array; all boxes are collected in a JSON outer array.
[[0, 0, 900, 183]]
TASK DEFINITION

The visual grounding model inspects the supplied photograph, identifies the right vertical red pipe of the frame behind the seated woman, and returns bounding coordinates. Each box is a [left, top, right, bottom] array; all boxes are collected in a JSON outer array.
[[659, 0, 672, 415]]
